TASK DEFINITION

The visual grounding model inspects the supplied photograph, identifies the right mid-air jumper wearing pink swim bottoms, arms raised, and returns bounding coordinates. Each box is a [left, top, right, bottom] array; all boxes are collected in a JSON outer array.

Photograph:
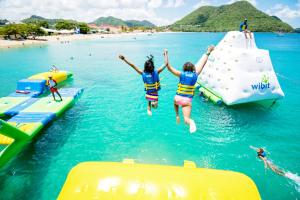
[[164, 46, 214, 133]]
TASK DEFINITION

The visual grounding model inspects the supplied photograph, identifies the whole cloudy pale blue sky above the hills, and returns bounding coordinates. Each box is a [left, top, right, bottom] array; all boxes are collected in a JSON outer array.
[[0, 0, 300, 28]]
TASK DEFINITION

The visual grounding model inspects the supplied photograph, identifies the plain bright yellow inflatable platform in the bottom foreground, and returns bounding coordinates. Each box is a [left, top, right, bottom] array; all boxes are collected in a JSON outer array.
[[58, 159, 260, 200]]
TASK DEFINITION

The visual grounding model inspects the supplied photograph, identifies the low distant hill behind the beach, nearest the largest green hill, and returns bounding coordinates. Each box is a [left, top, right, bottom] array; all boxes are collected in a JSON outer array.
[[91, 16, 156, 28]]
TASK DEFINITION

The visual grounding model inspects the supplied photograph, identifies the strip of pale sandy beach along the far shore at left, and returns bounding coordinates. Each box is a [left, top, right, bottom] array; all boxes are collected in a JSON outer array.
[[0, 32, 151, 49]]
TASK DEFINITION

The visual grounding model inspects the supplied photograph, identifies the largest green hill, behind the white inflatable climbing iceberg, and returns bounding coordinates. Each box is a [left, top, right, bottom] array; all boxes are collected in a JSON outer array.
[[169, 1, 294, 32]]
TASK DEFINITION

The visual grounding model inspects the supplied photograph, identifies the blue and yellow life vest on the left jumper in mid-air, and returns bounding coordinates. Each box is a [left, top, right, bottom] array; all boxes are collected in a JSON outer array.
[[142, 70, 160, 92]]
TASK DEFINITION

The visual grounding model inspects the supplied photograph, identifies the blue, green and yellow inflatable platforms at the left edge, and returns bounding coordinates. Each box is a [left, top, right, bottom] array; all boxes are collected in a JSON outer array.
[[0, 71, 83, 168]]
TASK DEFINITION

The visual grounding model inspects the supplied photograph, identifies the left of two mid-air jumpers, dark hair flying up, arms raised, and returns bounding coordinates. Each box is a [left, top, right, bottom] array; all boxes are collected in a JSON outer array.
[[119, 55, 166, 116]]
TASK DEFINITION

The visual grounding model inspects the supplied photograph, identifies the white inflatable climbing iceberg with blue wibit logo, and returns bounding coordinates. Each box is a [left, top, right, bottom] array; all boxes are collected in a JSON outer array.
[[198, 31, 284, 105]]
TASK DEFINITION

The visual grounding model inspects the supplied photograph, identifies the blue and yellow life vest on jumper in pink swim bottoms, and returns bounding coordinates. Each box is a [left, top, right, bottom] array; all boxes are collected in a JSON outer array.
[[176, 72, 198, 98]]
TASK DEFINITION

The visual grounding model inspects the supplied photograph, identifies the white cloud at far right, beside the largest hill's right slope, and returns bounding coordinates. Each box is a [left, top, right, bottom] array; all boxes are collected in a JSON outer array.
[[266, 1, 300, 20]]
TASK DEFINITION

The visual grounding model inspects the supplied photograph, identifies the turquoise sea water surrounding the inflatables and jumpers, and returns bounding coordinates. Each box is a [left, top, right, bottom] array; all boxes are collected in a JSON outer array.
[[0, 33, 300, 200]]
